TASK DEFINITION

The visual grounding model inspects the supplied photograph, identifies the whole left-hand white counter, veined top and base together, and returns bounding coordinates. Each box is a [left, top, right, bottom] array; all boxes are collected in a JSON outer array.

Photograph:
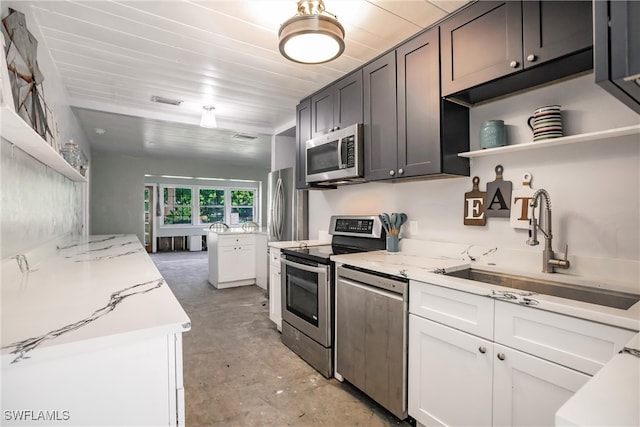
[[1, 235, 191, 426]]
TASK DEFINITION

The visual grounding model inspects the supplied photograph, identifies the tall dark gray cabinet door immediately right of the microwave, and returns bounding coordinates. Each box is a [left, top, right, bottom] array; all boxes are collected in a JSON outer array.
[[362, 51, 398, 181]]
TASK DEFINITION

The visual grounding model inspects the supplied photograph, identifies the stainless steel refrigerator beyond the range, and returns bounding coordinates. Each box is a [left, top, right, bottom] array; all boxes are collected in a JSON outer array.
[[267, 168, 309, 241]]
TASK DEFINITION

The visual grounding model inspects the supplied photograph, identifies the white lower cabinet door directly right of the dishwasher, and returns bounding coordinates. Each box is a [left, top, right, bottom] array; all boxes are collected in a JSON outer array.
[[408, 314, 493, 426]]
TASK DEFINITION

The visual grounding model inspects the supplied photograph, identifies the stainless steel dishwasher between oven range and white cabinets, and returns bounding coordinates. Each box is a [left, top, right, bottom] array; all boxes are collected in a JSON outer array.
[[335, 266, 409, 419]]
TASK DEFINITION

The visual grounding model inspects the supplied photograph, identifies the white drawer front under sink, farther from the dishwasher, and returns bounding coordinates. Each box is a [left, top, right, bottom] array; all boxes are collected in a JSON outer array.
[[495, 301, 636, 375]]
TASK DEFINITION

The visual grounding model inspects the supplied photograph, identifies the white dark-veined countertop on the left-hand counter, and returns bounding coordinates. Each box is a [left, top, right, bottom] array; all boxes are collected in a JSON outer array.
[[1, 235, 191, 369]]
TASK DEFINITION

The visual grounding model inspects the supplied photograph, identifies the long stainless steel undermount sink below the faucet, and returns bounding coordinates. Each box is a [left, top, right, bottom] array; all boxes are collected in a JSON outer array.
[[445, 268, 640, 310]]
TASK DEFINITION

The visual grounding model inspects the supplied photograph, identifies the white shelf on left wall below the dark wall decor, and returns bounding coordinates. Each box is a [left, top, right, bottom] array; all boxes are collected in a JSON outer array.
[[0, 105, 87, 182]]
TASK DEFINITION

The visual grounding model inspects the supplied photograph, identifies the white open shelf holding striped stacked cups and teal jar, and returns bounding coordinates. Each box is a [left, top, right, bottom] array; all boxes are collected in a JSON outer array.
[[458, 125, 640, 158]]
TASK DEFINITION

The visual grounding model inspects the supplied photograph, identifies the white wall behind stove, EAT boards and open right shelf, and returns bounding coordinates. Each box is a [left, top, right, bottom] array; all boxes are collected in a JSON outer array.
[[309, 74, 640, 260]]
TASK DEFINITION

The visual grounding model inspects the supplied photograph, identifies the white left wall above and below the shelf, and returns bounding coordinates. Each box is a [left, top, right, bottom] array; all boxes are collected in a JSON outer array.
[[0, 1, 91, 258]]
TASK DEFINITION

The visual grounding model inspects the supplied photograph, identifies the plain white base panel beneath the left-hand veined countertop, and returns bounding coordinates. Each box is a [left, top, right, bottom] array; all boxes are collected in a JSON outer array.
[[2, 334, 184, 426]]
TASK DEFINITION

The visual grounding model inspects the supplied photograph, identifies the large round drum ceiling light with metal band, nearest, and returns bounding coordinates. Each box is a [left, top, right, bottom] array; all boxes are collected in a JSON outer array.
[[278, 0, 344, 64]]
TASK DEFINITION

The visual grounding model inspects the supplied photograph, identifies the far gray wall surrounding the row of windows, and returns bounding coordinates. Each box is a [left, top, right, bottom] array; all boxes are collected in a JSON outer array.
[[91, 152, 269, 247]]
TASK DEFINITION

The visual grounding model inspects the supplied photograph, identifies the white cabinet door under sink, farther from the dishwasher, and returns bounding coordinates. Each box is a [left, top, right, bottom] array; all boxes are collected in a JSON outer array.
[[493, 344, 591, 426]]
